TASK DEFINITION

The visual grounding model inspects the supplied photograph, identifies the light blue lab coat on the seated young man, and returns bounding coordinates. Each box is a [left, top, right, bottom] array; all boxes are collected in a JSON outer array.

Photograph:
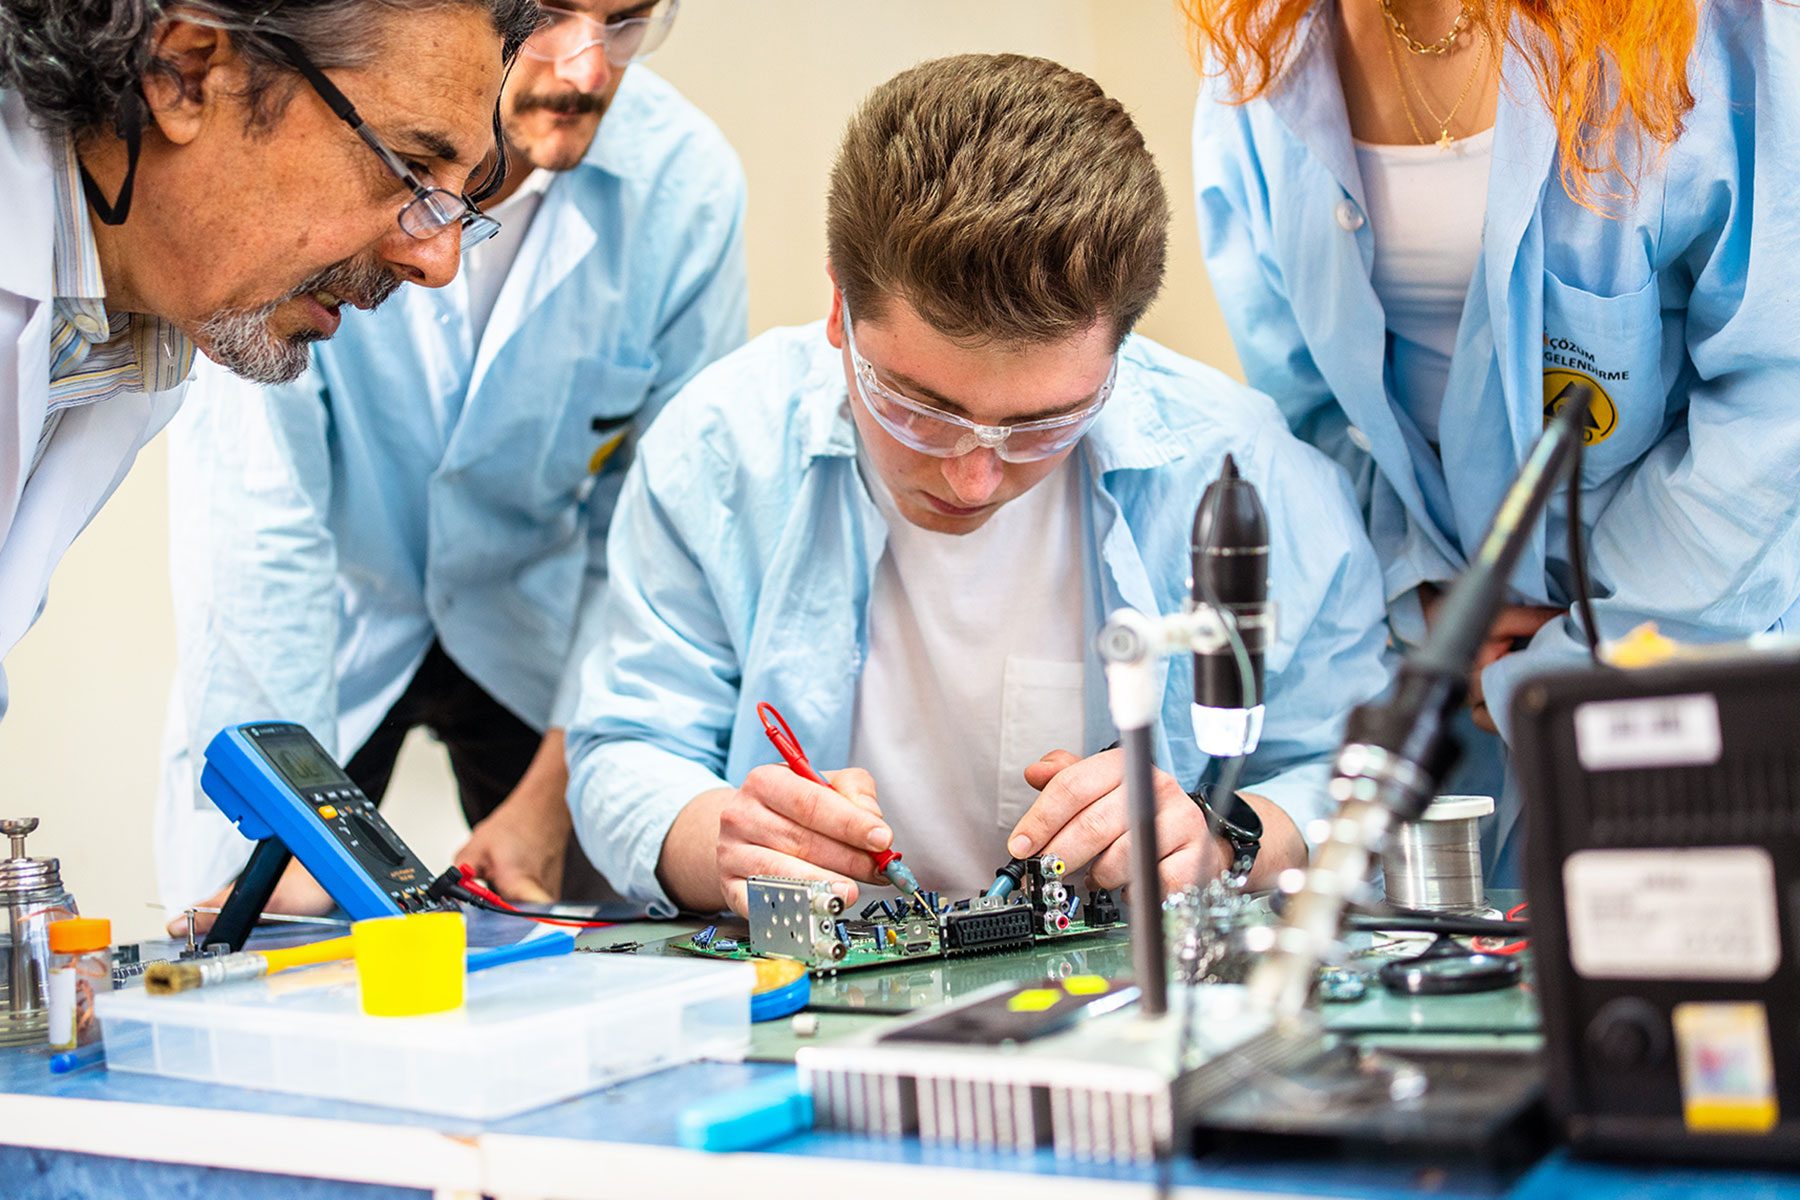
[[569, 324, 1388, 903]]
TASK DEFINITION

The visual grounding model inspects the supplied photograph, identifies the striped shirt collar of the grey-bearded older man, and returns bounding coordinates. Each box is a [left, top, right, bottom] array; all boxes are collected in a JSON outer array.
[[49, 142, 194, 412]]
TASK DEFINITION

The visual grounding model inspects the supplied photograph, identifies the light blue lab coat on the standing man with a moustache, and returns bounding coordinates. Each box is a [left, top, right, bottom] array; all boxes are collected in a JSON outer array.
[[158, 67, 747, 901]]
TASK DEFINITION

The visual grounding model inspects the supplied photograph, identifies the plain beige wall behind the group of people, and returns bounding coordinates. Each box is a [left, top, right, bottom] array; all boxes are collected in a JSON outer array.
[[0, 0, 1237, 941]]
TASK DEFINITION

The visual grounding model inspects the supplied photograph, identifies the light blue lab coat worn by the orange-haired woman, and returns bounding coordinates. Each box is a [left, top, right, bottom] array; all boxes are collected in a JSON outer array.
[[1193, 4, 1800, 877]]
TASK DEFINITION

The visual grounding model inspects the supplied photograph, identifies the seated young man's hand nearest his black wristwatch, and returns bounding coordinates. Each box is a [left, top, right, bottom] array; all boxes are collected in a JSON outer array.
[[1006, 750, 1229, 891]]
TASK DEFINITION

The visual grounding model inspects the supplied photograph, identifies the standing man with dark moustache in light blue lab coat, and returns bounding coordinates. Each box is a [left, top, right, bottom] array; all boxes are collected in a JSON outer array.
[[157, 0, 747, 912]]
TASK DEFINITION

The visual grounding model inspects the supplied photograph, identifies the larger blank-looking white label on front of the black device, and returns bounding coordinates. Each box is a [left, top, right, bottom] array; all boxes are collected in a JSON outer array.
[[1562, 846, 1782, 982]]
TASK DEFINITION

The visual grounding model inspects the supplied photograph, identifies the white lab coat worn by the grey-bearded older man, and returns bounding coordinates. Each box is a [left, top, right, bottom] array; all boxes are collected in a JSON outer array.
[[0, 92, 185, 714]]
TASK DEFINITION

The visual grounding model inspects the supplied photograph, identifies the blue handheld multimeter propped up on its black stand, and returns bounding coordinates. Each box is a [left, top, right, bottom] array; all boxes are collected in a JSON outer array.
[[200, 721, 455, 950]]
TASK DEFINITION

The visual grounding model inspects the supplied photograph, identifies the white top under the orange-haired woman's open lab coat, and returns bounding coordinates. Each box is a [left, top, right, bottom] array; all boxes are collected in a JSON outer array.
[[1355, 130, 1494, 446]]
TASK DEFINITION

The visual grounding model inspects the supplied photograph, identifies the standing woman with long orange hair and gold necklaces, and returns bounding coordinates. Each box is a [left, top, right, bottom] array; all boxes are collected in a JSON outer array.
[[1184, 0, 1800, 880]]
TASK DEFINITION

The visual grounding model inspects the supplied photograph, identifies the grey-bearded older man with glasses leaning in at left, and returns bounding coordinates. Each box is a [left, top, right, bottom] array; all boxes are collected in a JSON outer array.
[[0, 0, 538, 712]]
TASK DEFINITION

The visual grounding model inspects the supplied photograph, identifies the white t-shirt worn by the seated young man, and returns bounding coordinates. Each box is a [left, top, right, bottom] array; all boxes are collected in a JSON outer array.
[[850, 455, 1085, 898]]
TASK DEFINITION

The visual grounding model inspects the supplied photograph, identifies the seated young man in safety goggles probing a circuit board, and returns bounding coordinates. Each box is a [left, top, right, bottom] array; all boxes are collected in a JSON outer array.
[[569, 56, 1386, 912]]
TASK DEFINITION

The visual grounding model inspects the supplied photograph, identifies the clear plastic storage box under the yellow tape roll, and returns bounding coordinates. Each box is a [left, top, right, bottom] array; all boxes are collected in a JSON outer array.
[[97, 954, 756, 1121]]
